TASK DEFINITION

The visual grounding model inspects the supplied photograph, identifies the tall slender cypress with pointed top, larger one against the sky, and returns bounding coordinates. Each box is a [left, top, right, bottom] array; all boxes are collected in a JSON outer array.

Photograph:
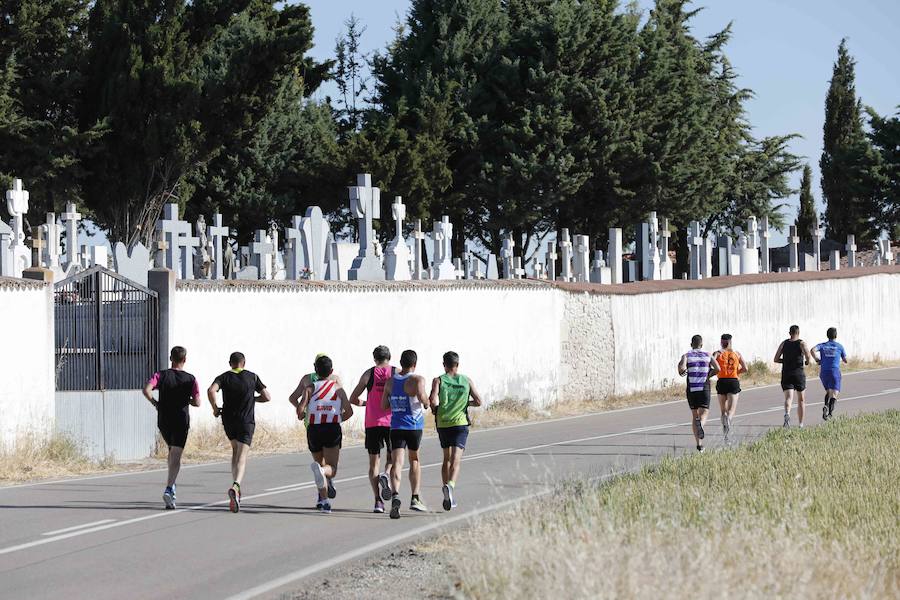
[[819, 40, 877, 242]]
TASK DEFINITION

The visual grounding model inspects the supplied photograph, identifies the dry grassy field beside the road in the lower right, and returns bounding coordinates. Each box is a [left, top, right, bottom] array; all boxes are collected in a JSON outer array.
[[430, 411, 900, 600]]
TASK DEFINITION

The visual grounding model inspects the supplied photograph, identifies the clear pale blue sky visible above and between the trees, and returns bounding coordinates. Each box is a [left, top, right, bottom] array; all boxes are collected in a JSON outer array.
[[305, 0, 900, 231]]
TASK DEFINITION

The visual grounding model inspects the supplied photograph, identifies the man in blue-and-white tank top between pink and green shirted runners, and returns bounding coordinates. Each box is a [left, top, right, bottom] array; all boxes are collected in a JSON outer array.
[[381, 350, 429, 519]]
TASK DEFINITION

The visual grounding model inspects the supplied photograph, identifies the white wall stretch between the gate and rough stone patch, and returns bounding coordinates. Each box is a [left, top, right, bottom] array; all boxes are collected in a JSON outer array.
[[171, 283, 564, 425]]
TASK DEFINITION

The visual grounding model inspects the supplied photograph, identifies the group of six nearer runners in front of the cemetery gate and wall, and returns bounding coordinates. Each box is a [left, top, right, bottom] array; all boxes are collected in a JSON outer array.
[[143, 346, 481, 519]]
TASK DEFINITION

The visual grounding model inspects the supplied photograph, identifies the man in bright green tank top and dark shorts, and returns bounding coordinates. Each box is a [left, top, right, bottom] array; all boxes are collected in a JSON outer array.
[[429, 351, 481, 510]]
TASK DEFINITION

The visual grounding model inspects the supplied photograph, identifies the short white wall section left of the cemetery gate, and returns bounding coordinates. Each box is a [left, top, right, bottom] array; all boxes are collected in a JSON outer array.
[[0, 277, 55, 446]]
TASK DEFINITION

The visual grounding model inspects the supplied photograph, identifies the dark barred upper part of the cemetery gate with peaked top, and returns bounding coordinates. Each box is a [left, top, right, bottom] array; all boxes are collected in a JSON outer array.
[[54, 266, 159, 391]]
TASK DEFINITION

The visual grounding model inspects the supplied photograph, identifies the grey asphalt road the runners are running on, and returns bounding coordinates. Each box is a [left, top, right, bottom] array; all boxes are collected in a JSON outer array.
[[0, 368, 900, 600]]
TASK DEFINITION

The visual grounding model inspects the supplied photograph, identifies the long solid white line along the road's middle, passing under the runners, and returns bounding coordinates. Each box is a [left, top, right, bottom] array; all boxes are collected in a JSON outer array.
[[0, 390, 895, 555]]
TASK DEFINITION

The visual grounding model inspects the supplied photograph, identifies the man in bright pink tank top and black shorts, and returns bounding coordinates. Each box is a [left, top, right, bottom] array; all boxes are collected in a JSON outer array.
[[350, 346, 397, 513]]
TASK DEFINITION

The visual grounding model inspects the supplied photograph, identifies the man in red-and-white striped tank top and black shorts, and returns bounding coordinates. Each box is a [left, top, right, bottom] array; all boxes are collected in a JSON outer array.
[[297, 356, 353, 512]]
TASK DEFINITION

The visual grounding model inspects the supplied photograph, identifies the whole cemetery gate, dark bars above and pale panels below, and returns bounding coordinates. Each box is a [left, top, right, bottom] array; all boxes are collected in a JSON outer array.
[[54, 267, 159, 460]]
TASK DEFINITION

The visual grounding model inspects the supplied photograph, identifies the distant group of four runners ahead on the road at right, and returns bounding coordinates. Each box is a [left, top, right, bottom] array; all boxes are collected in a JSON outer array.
[[678, 325, 847, 452]]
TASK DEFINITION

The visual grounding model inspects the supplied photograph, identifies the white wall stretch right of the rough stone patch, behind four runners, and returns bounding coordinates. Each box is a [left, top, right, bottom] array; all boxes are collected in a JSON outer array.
[[611, 274, 900, 394]]
